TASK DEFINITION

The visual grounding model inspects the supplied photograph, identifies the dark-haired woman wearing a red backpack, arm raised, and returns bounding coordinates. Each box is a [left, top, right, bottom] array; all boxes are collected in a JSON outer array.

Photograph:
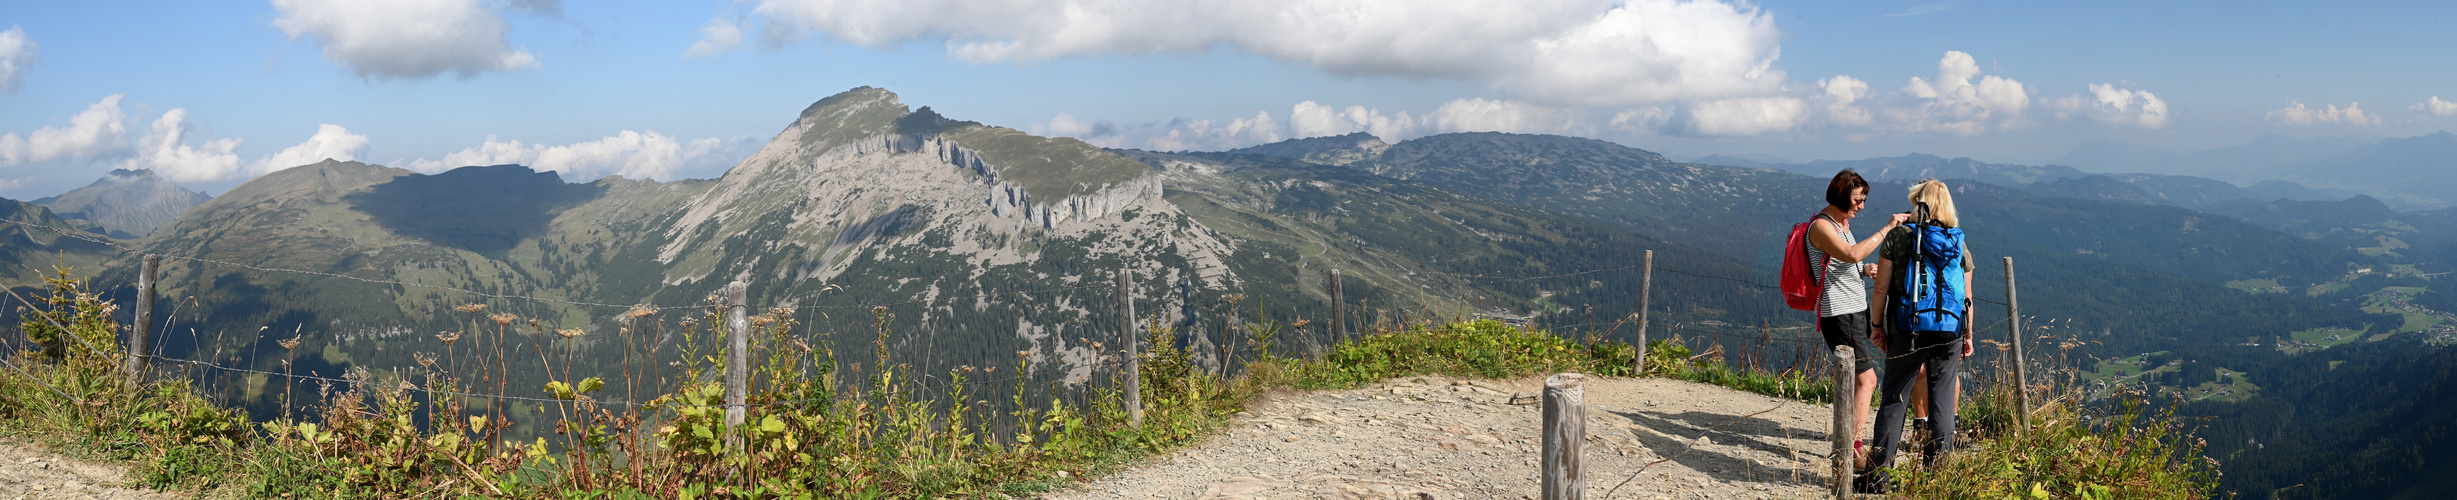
[[1786, 169, 1909, 470]]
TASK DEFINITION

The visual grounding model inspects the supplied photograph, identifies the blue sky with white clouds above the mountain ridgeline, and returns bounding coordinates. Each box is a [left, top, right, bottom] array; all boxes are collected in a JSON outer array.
[[0, 0, 2457, 199]]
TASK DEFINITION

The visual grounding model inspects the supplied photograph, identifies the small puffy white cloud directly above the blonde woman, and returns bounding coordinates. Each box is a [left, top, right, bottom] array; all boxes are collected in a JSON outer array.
[[1889, 51, 2029, 135]]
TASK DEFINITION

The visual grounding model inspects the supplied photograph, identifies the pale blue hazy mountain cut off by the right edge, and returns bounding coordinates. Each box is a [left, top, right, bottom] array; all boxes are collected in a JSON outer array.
[[2263, 132, 2457, 211]]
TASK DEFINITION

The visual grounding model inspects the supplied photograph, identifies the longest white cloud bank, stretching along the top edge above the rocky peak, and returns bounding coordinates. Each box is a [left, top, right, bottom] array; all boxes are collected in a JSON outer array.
[[717, 0, 1786, 105]]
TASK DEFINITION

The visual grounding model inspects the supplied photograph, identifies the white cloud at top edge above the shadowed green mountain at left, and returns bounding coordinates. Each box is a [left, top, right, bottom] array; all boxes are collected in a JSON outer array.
[[273, 0, 538, 78]]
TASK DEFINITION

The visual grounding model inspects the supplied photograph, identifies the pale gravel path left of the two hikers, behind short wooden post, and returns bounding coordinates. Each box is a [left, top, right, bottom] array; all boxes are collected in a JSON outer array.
[[1047, 377, 1830, 500]]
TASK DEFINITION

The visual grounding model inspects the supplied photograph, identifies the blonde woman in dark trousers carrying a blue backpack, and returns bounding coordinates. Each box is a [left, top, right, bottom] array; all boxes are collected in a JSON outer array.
[[1857, 179, 1973, 490]]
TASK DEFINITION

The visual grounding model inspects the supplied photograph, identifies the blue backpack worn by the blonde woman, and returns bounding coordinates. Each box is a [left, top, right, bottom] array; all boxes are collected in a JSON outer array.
[[1887, 221, 1968, 333]]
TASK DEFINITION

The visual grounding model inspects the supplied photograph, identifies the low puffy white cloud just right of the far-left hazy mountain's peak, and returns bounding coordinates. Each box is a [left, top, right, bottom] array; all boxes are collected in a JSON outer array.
[[120, 108, 369, 181]]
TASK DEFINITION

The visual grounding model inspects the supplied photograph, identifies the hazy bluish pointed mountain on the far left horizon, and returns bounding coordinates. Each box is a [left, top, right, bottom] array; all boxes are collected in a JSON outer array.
[[32, 169, 214, 240]]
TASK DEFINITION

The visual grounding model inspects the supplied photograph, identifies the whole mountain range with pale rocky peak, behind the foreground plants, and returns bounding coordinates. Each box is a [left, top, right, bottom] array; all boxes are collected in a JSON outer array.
[[0, 88, 2447, 495]]
